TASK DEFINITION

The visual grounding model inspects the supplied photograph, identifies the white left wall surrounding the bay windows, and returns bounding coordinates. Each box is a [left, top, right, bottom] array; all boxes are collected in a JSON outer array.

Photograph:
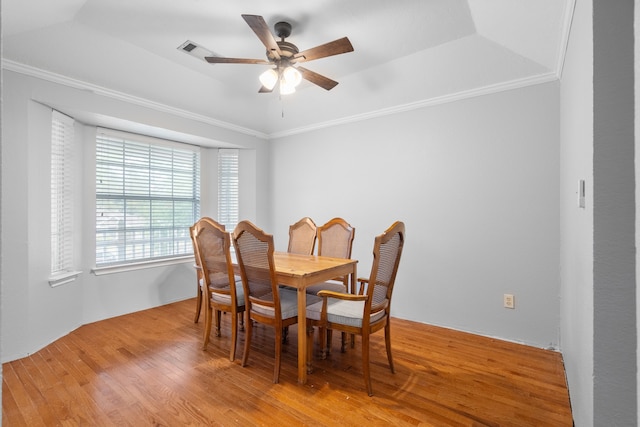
[[1, 70, 268, 362]]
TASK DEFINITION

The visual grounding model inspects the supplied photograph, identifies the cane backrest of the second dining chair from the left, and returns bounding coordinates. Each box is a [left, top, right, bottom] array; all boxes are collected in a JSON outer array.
[[233, 220, 281, 319]]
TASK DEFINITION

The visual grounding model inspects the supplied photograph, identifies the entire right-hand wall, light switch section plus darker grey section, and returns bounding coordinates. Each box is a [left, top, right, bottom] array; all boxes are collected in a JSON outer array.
[[561, 0, 637, 427]]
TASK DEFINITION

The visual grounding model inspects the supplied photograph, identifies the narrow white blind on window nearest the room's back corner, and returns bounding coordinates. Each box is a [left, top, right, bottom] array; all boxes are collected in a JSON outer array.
[[218, 148, 240, 231]]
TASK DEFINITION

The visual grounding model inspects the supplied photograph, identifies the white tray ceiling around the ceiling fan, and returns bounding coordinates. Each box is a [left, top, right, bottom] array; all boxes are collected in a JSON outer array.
[[2, 0, 574, 136]]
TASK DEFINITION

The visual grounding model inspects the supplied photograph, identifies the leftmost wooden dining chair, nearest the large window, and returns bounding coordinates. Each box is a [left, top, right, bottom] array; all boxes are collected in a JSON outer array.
[[193, 218, 245, 361]]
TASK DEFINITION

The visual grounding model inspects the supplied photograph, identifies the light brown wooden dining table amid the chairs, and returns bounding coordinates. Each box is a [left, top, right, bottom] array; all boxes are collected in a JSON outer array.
[[216, 251, 358, 384]]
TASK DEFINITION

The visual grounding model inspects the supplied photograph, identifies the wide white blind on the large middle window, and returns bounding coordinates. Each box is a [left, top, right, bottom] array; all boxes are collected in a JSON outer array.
[[96, 129, 200, 267]]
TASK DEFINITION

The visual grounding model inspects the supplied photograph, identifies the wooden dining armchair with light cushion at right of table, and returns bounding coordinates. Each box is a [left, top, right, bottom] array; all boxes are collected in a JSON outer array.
[[307, 222, 405, 396]]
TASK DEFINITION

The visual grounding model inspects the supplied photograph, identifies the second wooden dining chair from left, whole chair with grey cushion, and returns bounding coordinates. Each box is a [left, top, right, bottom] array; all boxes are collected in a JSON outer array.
[[233, 221, 318, 384]]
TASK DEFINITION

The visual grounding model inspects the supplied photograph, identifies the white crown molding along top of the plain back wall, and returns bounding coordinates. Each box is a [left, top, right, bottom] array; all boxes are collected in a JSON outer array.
[[269, 71, 558, 140]]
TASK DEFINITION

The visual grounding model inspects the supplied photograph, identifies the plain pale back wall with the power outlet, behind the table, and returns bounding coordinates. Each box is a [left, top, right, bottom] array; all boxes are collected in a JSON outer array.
[[267, 83, 560, 348]]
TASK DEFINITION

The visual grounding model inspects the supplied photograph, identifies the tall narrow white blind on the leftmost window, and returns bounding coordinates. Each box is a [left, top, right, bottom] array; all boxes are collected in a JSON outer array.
[[51, 111, 73, 275]]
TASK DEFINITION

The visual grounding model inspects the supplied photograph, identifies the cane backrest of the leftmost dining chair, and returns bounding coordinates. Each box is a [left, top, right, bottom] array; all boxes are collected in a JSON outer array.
[[191, 217, 237, 301]]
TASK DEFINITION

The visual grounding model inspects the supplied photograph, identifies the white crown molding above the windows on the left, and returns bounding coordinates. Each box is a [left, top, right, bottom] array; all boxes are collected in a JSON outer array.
[[2, 58, 269, 139]]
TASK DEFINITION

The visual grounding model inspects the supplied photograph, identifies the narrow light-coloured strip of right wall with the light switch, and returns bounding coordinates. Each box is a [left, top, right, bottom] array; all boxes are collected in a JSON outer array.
[[560, 0, 594, 427]]
